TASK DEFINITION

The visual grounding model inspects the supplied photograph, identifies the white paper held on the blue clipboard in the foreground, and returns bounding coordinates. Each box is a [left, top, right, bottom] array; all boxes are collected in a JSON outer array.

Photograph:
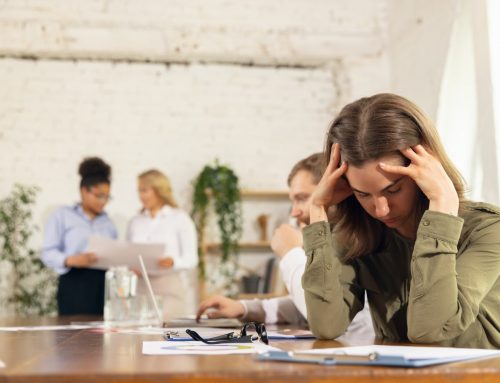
[[300, 345, 500, 361]]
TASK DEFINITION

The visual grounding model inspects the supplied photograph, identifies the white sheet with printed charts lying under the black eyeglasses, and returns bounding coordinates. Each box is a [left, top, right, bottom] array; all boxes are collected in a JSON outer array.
[[142, 341, 279, 355]]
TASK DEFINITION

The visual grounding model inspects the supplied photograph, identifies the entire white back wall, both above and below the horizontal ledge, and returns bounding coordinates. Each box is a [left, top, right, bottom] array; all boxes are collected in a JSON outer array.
[[0, 0, 389, 292]]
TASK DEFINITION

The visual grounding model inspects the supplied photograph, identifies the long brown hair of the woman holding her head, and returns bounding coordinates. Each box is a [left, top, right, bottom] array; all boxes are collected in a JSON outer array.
[[325, 93, 466, 259]]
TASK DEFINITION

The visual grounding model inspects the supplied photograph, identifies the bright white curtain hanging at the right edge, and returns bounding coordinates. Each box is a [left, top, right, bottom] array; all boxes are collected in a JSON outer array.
[[437, 0, 500, 204]]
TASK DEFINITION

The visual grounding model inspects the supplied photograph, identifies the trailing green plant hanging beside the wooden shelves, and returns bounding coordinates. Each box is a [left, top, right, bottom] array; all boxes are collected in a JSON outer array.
[[191, 160, 242, 295]]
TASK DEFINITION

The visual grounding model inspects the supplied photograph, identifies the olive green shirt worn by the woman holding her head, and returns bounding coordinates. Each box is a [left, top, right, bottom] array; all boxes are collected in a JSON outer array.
[[302, 202, 500, 348]]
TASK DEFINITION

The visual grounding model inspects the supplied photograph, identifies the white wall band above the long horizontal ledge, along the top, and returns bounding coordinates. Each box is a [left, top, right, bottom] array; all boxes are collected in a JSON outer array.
[[0, 0, 386, 65]]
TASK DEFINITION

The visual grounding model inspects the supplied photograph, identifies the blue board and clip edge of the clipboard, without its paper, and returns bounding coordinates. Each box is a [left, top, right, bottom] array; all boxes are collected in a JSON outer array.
[[256, 351, 416, 367]]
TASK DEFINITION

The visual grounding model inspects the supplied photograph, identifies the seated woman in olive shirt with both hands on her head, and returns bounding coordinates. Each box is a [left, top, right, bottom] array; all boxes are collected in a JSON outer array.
[[302, 94, 500, 348]]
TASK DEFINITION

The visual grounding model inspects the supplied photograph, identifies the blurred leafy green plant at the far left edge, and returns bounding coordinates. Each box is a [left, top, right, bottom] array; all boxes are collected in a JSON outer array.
[[0, 185, 57, 315]]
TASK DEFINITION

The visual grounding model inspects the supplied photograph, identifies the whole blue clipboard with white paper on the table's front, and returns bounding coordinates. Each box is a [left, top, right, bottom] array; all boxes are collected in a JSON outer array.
[[256, 346, 500, 368]]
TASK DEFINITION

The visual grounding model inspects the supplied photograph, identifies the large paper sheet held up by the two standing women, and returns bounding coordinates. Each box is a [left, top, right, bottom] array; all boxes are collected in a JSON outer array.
[[87, 236, 168, 275]]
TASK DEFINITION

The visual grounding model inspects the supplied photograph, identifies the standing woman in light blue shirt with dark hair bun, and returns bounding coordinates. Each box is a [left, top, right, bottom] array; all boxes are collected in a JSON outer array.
[[42, 157, 117, 315]]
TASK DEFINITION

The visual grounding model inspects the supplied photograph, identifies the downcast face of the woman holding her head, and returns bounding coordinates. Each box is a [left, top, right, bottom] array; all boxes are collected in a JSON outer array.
[[346, 156, 419, 238]]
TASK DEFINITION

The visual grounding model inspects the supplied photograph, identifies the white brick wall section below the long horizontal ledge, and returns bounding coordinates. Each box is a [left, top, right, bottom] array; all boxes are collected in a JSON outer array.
[[0, 59, 356, 243]]
